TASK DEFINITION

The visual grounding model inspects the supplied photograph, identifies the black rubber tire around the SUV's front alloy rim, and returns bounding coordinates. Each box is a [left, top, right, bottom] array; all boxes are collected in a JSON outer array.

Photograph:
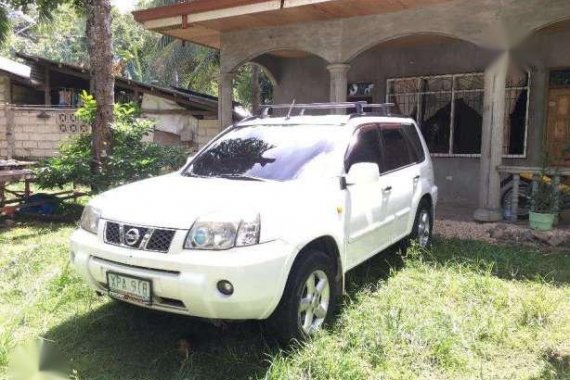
[[265, 249, 337, 344]]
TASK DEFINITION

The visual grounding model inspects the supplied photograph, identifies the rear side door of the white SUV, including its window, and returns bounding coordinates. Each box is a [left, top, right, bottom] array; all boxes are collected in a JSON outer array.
[[380, 123, 420, 243]]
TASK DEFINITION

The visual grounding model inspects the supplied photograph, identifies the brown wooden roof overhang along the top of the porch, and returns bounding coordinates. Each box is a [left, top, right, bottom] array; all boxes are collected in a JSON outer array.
[[133, 0, 452, 48]]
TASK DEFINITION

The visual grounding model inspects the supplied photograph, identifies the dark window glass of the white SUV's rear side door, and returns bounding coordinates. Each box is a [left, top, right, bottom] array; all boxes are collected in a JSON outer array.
[[381, 124, 417, 172]]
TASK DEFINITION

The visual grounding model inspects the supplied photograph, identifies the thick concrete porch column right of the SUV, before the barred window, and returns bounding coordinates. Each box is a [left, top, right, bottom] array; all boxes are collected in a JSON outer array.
[[474, 52, 510, 222]]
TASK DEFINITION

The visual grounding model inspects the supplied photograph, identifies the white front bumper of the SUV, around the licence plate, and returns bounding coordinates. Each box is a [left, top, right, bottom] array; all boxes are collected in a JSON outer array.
[[70, 229, 295, 320]]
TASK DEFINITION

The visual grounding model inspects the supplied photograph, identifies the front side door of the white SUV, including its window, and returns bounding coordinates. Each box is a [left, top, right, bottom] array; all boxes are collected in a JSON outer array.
[[345, 124, 390, 269]]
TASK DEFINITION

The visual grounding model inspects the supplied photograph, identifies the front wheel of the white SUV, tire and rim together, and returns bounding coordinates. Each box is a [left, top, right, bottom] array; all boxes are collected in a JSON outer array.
[[267, 250, 336, 343]]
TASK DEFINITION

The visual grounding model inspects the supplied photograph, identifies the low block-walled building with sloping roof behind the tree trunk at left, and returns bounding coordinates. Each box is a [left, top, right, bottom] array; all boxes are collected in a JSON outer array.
[[0, 53, 237, 159]]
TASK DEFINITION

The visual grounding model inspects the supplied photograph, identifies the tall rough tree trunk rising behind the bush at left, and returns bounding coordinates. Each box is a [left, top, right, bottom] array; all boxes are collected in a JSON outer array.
[[86, 0, 115, 184]]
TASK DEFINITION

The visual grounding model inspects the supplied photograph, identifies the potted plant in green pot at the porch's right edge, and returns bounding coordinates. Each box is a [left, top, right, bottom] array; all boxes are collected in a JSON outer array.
[[529, 157, 557, 231]]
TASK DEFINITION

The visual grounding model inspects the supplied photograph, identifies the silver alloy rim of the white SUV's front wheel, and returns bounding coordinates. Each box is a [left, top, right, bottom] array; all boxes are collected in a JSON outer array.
[[298, 270, 330, 335]]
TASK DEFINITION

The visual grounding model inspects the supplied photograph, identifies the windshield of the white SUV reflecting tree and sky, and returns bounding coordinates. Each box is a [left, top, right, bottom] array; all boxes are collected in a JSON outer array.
[[183, 125, 347, 181]]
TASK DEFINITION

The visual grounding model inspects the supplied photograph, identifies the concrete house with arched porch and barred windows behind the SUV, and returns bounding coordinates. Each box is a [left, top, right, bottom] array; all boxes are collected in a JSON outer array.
[[133, 0, 570, 221]]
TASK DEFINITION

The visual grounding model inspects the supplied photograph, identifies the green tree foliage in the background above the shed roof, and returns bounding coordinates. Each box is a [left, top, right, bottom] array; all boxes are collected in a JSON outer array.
[[0, 0, 272, 106]]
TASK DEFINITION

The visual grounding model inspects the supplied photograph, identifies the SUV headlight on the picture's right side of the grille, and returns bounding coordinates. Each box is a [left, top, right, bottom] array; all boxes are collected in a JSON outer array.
[[184, 214, 260, 250]]
